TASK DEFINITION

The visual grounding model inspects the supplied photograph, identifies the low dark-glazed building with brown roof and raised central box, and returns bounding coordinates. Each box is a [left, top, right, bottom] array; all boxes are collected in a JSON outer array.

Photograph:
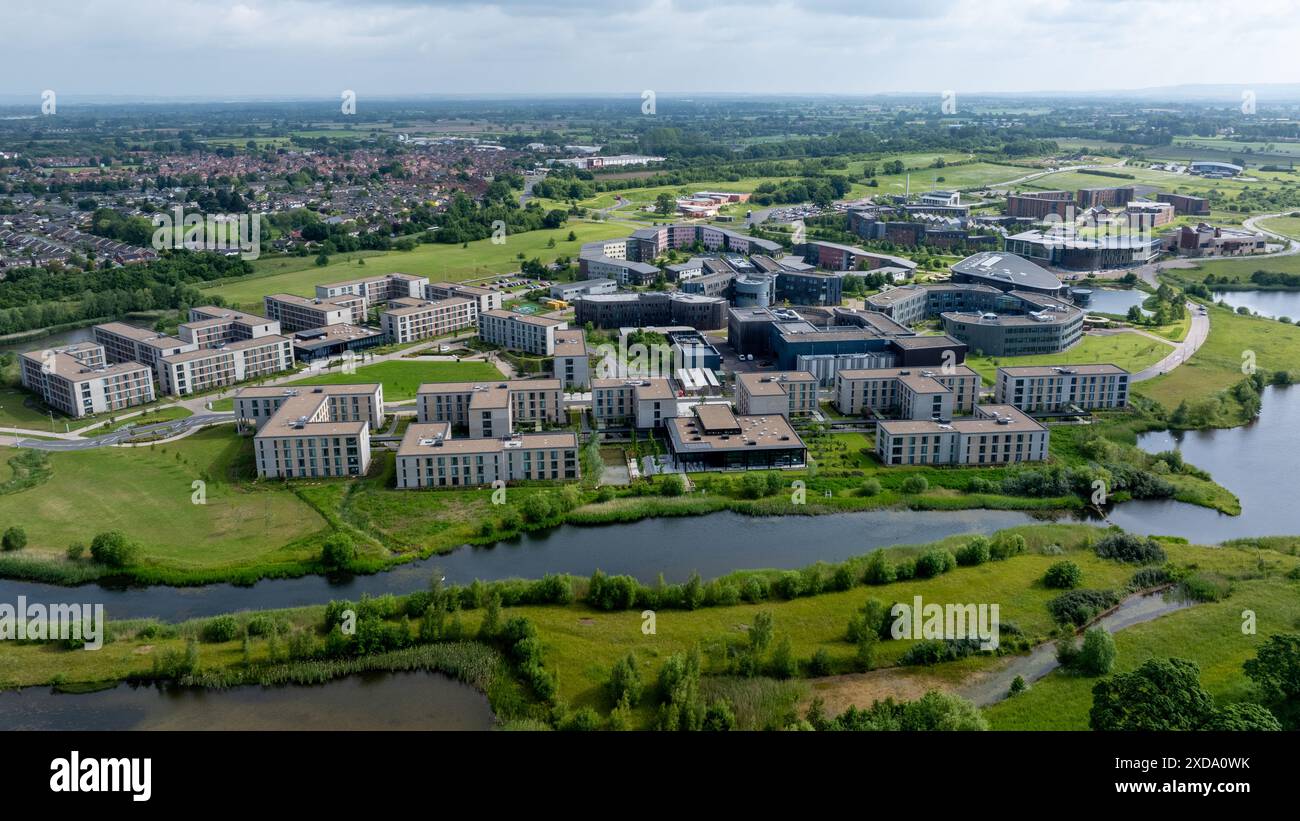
[[667, 403, 807, 472]]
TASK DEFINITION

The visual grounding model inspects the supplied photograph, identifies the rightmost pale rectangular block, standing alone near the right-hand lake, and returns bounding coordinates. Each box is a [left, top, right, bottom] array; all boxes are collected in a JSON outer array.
[[993, 364, 1130, 413]]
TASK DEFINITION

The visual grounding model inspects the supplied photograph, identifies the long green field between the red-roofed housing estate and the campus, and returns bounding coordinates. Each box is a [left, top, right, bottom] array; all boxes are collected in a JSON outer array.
[[205, 221, 631, 310]]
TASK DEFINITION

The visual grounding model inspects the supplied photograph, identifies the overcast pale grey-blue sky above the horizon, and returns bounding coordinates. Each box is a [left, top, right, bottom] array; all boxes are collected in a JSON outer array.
[[0, 0, 1300, 100]]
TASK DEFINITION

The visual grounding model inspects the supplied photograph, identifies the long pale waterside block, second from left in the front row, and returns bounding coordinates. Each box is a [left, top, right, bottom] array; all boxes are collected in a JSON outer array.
[[397, 422, 581, 490]]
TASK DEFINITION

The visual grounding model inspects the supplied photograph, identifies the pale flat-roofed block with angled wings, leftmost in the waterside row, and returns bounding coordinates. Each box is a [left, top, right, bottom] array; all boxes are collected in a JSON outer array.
[[246, 385, 384, 479]]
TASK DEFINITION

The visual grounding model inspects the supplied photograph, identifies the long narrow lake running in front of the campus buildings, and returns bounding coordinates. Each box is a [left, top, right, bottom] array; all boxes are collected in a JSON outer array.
[[0, 511, 1036, 621]]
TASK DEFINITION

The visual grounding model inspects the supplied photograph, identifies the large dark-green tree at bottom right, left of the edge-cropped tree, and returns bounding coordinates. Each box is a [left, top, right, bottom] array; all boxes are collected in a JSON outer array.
[[1088, 659, 1214, 731]]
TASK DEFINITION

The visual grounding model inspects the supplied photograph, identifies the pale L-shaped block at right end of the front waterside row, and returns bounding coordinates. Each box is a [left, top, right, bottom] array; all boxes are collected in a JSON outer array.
[[876, 405, 1049, 466]]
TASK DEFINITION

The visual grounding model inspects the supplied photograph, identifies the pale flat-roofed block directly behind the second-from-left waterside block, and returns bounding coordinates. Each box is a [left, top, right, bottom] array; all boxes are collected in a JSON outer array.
[[416, 379, 564, 439]]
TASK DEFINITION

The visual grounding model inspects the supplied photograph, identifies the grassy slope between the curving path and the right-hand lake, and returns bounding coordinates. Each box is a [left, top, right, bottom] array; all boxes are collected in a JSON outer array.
[[1135, 301, 1300, 409]]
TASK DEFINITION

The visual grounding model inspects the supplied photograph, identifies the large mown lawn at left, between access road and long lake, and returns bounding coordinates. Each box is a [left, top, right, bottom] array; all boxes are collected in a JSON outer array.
[[0, 427, 325, 572]]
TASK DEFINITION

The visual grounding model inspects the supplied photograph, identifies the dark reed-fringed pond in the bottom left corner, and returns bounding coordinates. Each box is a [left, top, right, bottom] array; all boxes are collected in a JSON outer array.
[[0, 673, 494, 730]]
